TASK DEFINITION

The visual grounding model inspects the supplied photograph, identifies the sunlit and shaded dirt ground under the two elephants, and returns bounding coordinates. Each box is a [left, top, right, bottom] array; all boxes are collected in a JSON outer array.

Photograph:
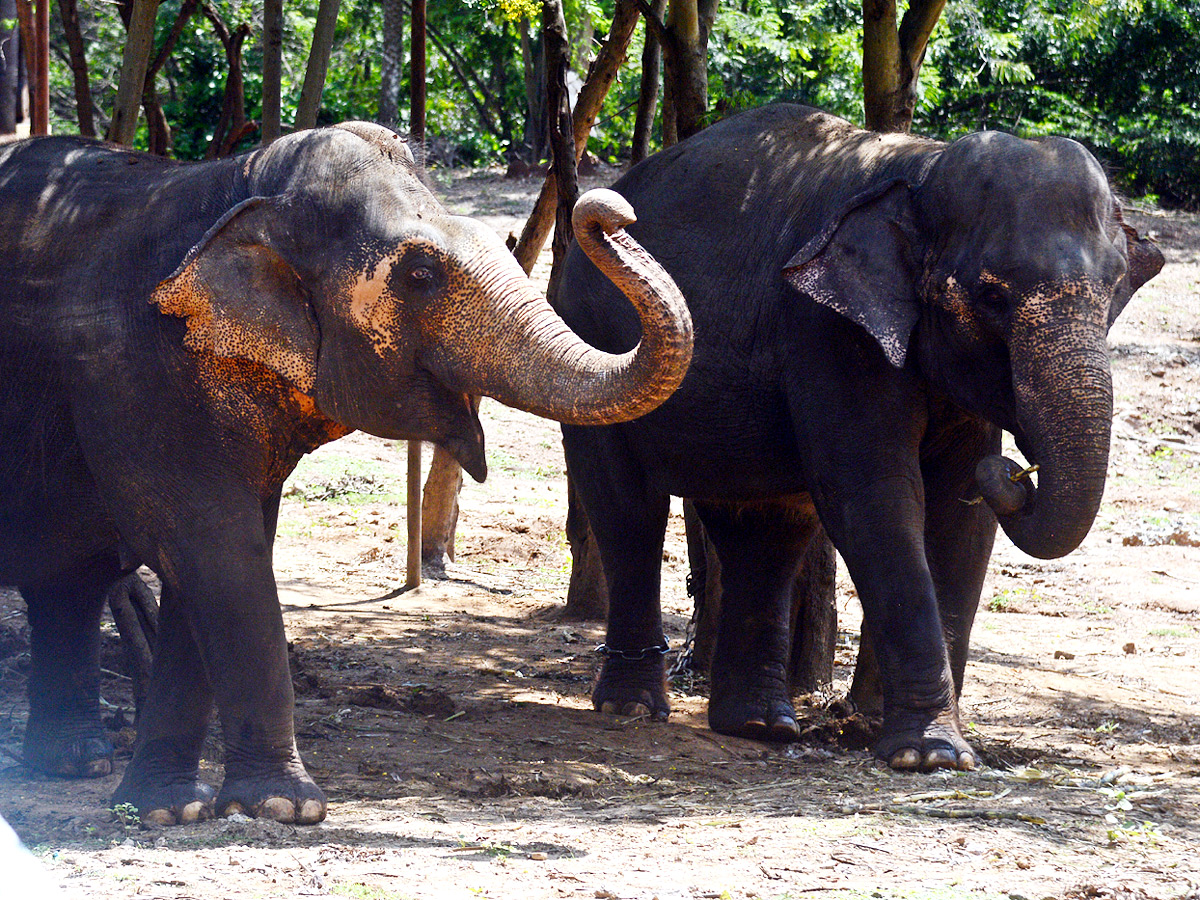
[[0, 174, 1200, 900]]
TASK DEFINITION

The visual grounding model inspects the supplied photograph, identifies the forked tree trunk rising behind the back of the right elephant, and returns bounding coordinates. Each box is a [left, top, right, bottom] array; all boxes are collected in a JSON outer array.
[[863, 0, 946, 132]]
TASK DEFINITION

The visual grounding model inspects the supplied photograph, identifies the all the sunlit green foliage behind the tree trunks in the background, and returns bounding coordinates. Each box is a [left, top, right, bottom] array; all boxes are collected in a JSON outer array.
[[23, 0, 1200, 206]]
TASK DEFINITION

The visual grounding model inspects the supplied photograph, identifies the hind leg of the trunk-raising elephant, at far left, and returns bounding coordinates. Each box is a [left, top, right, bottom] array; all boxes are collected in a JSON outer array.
[[20, 554, 121, 778]]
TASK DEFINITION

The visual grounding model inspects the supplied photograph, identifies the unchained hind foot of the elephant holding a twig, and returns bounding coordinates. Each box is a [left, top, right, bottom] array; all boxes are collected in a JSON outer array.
[[708, 662, 800, 743]]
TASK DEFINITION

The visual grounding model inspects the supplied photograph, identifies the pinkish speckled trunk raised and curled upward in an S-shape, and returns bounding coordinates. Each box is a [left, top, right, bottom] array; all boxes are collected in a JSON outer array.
[[439, 191, 692, 425]]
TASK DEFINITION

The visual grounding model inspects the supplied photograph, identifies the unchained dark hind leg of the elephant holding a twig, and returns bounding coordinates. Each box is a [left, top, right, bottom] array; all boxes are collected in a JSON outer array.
[[696, 502, 817, 742]]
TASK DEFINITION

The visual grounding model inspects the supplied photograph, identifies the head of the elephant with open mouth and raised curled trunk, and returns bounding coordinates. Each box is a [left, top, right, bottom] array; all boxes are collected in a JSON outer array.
[[151, 122, 691, 480]]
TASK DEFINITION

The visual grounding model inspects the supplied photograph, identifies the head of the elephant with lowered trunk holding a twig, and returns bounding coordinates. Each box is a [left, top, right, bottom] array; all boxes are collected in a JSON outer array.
[[787, 132, 1163, 558]]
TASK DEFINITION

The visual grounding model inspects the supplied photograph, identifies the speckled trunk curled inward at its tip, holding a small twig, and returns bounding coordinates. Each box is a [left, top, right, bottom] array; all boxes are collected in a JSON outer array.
[[976, 320, 1112, 559]]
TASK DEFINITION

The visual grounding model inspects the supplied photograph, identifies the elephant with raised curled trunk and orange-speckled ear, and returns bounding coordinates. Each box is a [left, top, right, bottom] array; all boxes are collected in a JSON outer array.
[[0, 122, 691, 824]]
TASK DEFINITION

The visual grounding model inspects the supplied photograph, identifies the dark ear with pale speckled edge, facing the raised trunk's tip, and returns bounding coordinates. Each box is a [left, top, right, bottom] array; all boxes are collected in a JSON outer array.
[[784, 179, 920, 368]]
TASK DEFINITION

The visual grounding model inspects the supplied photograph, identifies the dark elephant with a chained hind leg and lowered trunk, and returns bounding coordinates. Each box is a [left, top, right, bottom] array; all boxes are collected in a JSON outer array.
[[558, 103, 1163, 770]]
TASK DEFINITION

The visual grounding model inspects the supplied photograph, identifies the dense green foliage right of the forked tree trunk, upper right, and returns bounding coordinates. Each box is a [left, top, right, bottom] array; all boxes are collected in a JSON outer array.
[[917, 0, 1200, 206]]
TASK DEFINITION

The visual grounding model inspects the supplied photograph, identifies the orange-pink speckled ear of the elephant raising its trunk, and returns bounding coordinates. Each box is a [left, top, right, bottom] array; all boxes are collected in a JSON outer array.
[[150, 197, 320, 394]]
